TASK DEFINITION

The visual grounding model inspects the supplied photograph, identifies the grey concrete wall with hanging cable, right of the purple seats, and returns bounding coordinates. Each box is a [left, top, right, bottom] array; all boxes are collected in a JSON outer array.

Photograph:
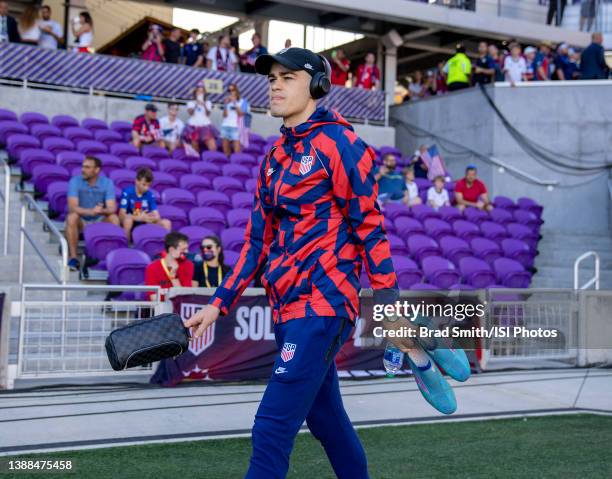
[[391, 82, 612, 233]]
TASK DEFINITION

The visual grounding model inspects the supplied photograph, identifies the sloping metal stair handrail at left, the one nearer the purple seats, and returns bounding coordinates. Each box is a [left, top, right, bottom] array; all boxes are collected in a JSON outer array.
[[19, 194, 68, 285]]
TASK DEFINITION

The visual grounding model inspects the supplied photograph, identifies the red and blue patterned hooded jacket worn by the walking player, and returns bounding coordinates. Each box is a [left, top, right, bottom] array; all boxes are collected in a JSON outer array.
[[209, 108, 397, 323]]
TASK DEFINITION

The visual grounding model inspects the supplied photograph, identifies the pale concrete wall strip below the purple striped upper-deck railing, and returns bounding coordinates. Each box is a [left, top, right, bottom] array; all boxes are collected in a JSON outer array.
[[0, 86, 395, 146]]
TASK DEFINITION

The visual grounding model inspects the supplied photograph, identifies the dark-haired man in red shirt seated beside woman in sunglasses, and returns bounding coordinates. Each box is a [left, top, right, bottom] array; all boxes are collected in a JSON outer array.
[[145, 231, 197, 301]]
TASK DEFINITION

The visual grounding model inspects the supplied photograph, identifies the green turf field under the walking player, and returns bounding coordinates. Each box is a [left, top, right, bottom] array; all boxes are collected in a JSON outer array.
[[0, 414, 612, 479]]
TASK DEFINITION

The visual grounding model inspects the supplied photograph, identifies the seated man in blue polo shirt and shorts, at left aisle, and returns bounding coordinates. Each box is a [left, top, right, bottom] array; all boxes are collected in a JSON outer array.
[[66, 156, 119, 271]]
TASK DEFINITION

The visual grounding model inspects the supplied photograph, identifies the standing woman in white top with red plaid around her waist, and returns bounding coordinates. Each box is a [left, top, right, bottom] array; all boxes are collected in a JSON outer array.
[[183, 81, 217, 153]]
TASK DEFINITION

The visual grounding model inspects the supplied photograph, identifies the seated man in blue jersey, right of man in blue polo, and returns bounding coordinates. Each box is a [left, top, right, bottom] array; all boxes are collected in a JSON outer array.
[[119, 168, 172, 241]]
